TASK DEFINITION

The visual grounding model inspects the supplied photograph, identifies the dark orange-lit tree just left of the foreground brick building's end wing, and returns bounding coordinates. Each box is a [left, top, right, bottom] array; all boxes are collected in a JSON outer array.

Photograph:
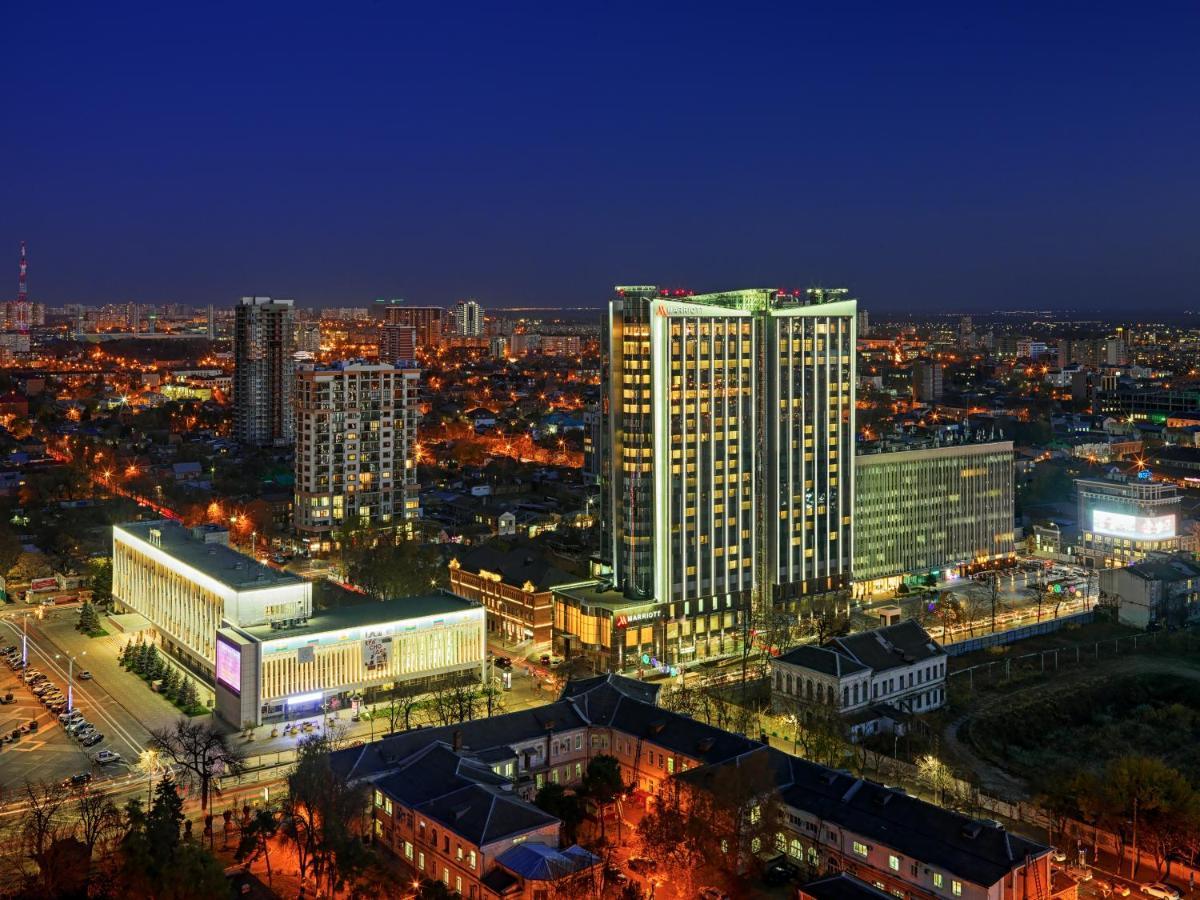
[[280, 734, 371, 894]]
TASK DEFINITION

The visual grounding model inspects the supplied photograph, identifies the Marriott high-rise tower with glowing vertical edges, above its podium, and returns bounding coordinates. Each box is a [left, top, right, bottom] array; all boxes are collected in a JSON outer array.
[[605, 287, 856, 618]]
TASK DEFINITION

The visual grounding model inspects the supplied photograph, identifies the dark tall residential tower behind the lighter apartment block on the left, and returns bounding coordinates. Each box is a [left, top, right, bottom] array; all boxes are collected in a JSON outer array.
[[233, 296, 296, 446]]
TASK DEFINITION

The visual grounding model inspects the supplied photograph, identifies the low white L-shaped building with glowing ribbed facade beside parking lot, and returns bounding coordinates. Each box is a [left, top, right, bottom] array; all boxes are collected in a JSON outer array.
[[113, 521, 487, 727]]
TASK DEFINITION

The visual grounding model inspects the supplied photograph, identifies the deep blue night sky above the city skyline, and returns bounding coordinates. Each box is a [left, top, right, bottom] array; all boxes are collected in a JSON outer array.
[[0, 0, 1200, 312]]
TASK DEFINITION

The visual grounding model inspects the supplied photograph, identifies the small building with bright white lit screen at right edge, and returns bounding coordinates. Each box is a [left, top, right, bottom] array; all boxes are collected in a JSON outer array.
[[1075, 469, 1183, 569]]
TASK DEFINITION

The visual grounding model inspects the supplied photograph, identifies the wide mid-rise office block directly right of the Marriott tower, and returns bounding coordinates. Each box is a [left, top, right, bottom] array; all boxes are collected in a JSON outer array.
[[854, 440, 1015, 596]]
